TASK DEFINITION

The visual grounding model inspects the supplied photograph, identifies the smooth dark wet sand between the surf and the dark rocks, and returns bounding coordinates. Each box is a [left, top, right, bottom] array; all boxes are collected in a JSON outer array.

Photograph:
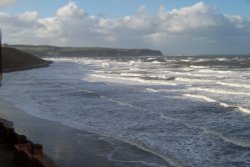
[[0, 98, 167, 167]]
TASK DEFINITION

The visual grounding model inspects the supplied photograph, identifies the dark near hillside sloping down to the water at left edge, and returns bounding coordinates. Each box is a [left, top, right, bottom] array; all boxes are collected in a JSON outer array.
[[2, 47, 51, 72]]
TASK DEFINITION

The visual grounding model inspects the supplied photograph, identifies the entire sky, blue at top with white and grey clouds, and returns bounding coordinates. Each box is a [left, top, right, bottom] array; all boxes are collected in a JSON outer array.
[[0, 0, 250, 55]]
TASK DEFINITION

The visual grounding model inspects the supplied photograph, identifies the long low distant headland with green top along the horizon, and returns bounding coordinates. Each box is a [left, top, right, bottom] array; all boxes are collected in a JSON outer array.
[[11, 45, 162, 57]]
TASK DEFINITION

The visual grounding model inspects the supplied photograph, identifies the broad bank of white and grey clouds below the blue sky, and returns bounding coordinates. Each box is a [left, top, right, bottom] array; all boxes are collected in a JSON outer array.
[[0, 1, 250, 54]]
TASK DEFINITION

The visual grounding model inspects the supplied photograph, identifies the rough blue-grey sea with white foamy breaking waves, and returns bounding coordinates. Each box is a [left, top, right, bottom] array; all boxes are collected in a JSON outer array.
[[0, 56, 250, 167]]
